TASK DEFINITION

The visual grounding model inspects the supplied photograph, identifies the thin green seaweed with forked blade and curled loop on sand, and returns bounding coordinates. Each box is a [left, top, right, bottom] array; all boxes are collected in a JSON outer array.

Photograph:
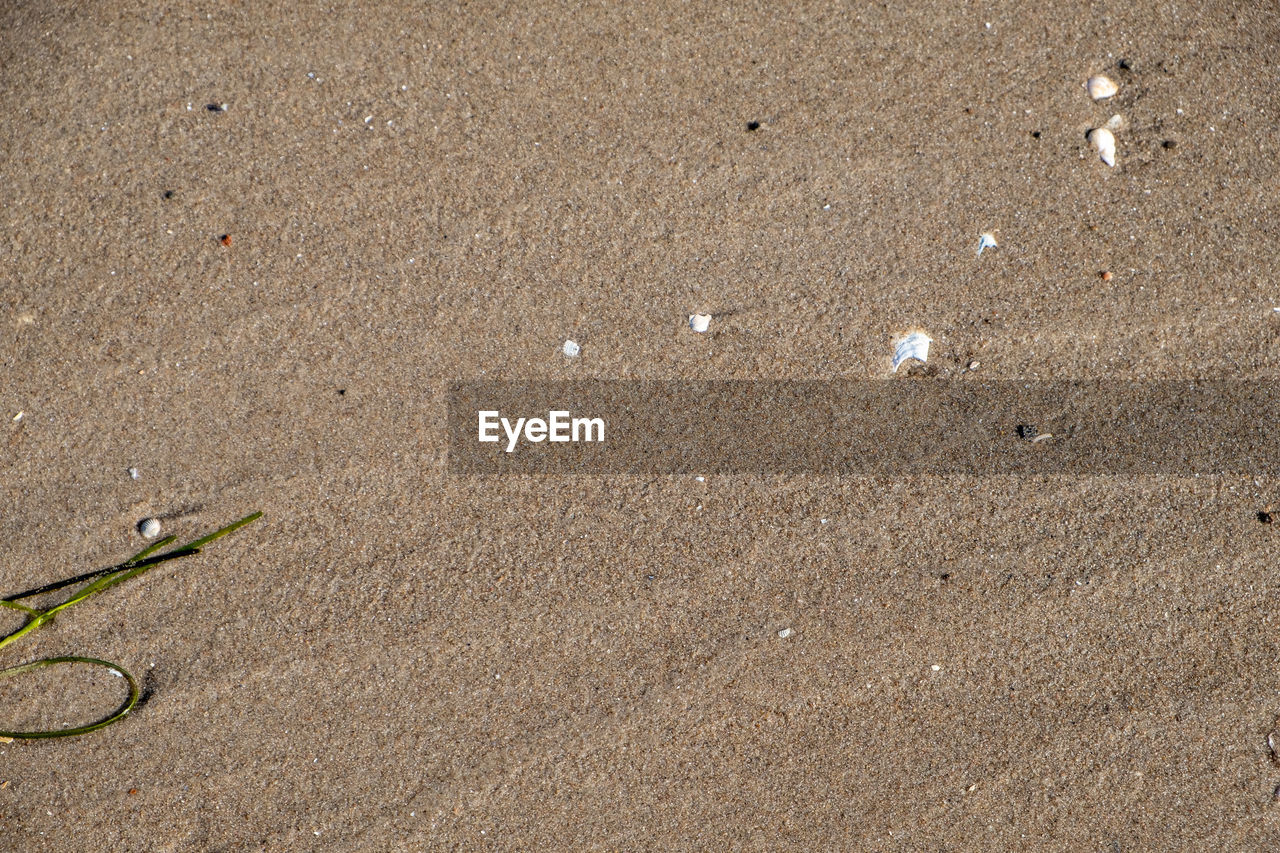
[[0, 512, 262, 740]]
